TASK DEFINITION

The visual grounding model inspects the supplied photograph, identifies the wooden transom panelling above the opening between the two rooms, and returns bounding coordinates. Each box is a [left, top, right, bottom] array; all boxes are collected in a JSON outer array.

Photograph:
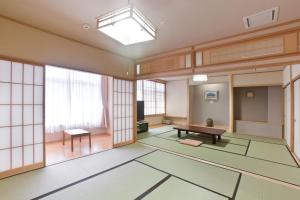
[[138, 29, 300, 78]]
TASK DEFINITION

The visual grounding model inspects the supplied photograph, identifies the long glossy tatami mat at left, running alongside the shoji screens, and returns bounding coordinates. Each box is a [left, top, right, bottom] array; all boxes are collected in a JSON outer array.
[[0, 144, 153, 200]]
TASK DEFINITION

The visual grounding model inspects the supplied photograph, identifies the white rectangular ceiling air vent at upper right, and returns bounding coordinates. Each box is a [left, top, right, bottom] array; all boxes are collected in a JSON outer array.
[[243, 7, 279, 29]]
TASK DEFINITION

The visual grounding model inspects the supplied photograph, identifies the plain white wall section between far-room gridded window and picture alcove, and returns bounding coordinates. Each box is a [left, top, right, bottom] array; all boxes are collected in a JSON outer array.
[[166, 80, 188, 117]]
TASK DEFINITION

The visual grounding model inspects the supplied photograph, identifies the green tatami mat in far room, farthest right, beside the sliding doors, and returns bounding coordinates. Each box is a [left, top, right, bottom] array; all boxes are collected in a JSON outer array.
[[247, 141, 298, 167]]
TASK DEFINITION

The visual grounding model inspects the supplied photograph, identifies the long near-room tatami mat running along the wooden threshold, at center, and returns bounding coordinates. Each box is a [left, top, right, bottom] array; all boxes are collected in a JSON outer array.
[[137, 151, 239, 197]]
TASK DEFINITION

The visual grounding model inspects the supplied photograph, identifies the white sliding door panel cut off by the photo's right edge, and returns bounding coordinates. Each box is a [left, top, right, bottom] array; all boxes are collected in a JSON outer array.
[[294, 79, 300, 158]]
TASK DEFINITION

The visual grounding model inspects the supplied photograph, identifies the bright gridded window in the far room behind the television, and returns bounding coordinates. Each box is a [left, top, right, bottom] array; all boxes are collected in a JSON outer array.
[[137, 80, 165, 115]]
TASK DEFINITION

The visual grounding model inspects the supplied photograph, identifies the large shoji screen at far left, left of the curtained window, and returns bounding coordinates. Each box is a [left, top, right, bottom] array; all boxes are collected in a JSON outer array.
[[0, 60, 44, 178]]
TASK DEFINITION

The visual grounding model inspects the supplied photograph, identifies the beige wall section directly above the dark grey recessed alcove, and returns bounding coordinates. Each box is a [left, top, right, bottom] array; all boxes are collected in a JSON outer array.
[[233, 71, 282, 87]]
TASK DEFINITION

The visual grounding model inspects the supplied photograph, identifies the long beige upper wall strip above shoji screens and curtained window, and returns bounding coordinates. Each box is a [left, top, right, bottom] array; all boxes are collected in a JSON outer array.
[[0, 18, 134, 78]]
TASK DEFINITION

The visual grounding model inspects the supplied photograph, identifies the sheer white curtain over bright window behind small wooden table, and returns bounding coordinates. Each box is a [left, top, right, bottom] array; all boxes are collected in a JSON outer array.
[[45, 66, 107, 133]]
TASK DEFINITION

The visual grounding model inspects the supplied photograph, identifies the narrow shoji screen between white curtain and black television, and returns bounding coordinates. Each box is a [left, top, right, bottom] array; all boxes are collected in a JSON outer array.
[[113, 79, 134, 147]]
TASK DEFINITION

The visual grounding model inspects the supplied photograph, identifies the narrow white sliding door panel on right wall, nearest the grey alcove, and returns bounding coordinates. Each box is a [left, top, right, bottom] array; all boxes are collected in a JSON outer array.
[[284, 85, 291, 147]]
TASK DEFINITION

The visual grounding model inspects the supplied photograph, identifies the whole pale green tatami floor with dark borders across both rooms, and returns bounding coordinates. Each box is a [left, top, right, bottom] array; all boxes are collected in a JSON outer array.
[[0, 126, 300, 200]]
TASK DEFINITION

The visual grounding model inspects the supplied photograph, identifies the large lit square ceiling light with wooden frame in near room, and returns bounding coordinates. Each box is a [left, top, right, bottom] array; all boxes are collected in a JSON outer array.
[[97, 5, 156, 45]]
